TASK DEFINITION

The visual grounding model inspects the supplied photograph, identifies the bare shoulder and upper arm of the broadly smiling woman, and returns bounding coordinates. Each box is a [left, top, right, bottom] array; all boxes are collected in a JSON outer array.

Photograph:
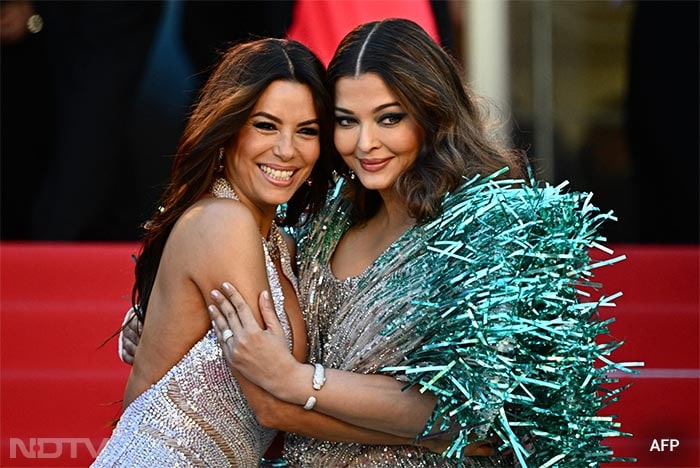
[[124, 199, 268, 406]]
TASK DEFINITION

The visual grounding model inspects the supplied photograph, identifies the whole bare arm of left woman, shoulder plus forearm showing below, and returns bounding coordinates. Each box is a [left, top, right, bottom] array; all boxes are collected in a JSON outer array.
[[125, 200, 434, 445]]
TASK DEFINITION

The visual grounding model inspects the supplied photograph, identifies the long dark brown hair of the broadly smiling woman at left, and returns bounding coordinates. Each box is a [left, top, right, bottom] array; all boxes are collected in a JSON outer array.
[[132, 39, 333, 320]]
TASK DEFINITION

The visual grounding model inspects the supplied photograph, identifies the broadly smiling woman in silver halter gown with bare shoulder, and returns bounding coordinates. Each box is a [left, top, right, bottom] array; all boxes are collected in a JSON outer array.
[[89, 39, 340, 466]]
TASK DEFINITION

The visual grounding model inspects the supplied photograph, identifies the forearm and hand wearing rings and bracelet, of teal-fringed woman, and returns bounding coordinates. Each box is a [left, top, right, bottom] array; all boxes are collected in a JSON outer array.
[[209, 283, 435, 439]]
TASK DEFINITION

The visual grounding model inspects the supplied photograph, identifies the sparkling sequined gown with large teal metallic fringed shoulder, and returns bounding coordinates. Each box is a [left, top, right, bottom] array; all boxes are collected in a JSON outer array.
[[285, 171, 624, 467]]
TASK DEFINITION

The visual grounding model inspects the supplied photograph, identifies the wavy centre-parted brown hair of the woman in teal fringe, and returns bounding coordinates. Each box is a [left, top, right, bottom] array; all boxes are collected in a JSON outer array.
[[328, 19, 524, 222]]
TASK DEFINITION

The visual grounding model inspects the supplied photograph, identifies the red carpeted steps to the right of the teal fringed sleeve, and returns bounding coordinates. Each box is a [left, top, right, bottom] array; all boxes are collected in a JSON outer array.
[[596, 246, 700, 468]]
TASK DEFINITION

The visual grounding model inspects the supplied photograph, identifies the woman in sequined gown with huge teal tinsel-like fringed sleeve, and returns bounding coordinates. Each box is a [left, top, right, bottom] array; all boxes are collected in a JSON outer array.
[[210, 19, 620, 467]]
